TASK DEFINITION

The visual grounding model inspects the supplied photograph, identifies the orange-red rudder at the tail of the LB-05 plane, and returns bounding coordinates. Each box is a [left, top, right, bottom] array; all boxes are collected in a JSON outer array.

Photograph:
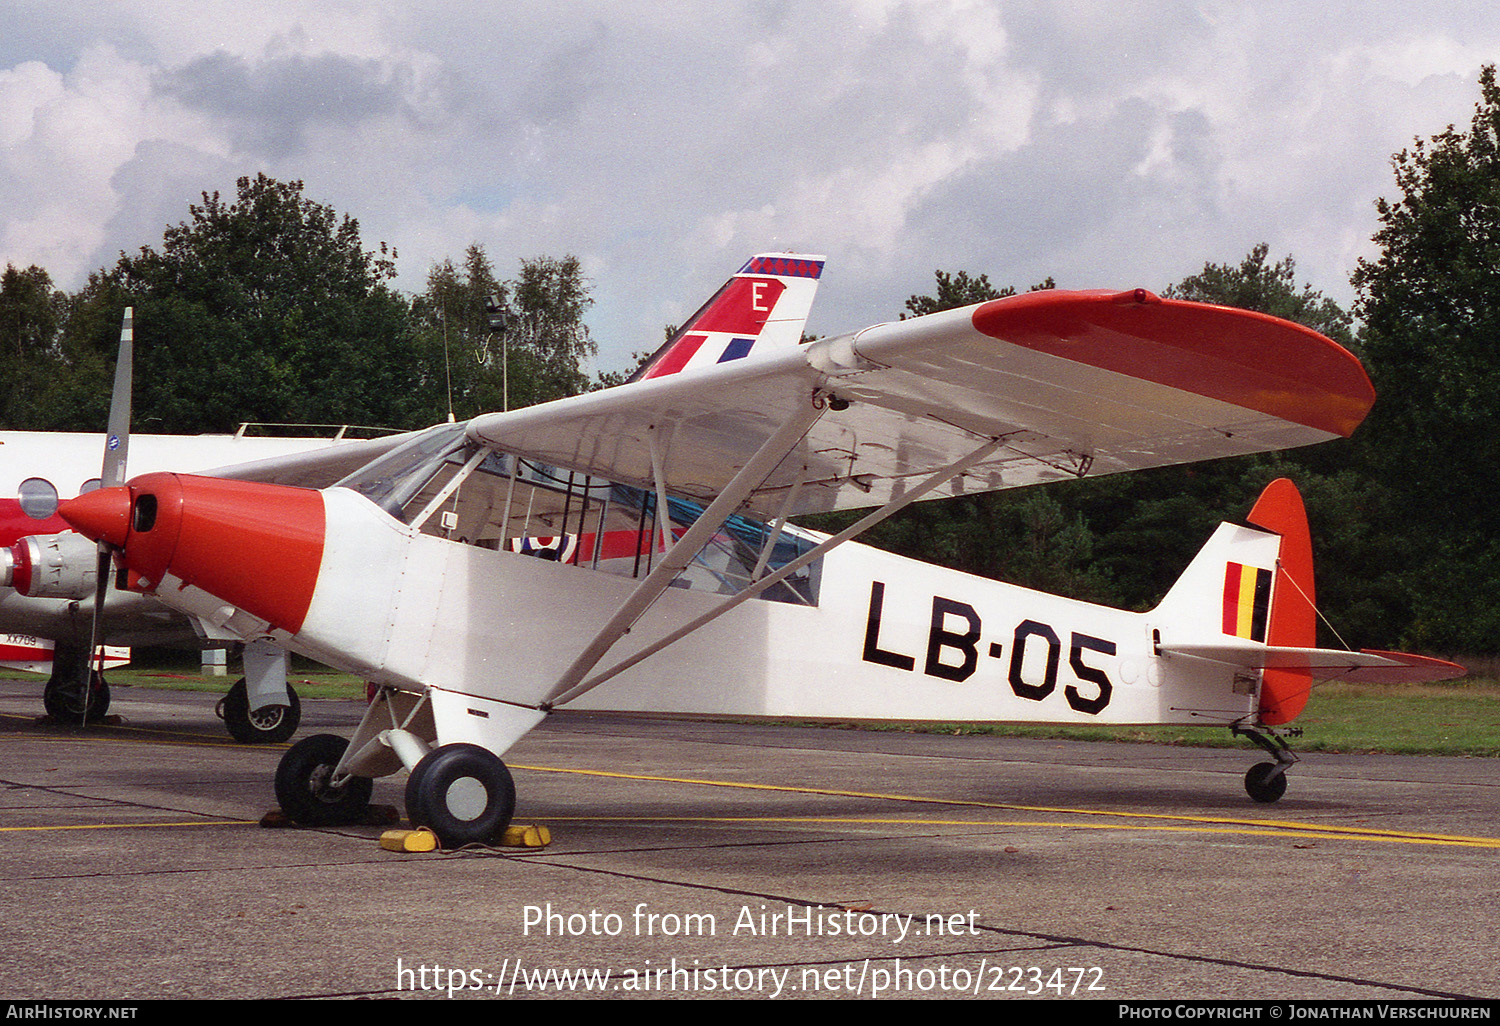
[[1248, 477, 1317, 726]]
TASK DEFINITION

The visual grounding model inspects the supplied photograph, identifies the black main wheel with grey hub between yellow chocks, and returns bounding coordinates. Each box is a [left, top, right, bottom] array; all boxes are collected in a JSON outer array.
[[407, 744, 516, 848]]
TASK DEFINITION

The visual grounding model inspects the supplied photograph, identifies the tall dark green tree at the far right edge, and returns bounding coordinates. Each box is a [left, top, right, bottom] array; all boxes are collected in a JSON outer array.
[[1353, 66, 1500, 653]]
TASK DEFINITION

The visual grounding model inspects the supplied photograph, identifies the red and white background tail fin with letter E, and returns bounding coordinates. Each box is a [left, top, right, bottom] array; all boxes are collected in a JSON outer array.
[[630, 254, 824, 381]]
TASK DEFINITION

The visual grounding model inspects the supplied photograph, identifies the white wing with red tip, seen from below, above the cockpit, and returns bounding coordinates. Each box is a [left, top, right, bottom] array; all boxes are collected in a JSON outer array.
[[468, 290, 1374, 515]]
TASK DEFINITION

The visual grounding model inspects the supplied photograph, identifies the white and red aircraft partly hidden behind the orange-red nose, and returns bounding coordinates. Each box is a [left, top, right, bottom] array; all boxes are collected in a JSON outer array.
[[0, 312, 411, 743]]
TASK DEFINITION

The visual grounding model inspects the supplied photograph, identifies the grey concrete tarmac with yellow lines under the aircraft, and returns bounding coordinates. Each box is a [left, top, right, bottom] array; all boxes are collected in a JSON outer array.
[[0, 681, 1500, 1002]]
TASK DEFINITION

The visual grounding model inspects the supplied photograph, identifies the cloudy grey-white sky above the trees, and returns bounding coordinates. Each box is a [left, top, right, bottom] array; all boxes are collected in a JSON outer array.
[[0, 0, 1500, 369]]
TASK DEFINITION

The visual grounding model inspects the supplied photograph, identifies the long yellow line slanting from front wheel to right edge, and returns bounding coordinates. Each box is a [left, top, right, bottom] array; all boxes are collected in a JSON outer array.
[[512, 765, 1500, 848]]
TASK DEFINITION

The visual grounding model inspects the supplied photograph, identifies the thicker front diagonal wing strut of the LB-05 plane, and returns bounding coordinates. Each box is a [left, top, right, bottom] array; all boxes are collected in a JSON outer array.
[[539, 398, 828, 708]]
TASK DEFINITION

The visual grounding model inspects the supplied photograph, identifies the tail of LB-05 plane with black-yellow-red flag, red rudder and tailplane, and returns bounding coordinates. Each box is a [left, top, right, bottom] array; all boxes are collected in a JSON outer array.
[[1154, 479, 1467, 726]]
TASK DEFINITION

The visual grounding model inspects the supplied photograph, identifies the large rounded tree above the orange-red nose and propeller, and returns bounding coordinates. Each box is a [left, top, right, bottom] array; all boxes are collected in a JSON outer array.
[[107, 174, 429, 432]]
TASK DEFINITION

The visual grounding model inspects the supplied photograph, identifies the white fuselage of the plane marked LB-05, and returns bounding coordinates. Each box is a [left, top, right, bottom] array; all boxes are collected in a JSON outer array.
[[120, 489, 1275, 752]]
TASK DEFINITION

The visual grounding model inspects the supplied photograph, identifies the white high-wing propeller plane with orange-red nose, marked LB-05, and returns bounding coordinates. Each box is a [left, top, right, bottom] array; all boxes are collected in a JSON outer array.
[[60, 254, 1463, 846]]
